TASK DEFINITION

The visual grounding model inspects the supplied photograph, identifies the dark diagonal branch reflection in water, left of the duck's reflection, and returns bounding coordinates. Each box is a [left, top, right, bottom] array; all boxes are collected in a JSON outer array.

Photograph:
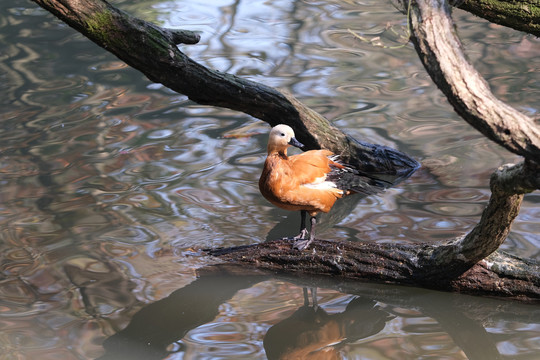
[[100, 275, 268, 360]]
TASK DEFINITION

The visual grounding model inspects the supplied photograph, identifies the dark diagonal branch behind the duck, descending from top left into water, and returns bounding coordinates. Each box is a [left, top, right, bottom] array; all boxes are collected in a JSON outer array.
[[33, 0, 418, 177]]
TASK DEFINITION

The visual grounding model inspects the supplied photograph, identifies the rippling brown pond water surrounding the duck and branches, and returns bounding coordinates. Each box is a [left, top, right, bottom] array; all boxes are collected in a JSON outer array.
[[0, 0, 540, 359]]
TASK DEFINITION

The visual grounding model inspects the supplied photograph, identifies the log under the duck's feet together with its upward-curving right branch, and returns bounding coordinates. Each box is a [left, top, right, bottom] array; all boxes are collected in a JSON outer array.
[[209, 164, 540, 301]]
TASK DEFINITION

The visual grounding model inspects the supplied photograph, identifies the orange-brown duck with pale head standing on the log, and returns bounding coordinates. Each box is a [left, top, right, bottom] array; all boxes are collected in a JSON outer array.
[[259, 124, 387, 250]]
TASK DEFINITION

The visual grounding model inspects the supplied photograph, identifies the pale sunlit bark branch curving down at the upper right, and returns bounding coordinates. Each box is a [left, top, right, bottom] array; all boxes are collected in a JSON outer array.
[[410, 0, 540, 162]]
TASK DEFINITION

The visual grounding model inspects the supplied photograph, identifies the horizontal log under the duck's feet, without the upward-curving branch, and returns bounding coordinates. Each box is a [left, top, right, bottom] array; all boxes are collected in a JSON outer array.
[[209, 239, 540, 303]]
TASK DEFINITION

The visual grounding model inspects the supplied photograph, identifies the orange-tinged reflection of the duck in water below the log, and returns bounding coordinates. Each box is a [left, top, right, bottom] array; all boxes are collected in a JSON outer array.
[[263, 288, 393, 360]]
